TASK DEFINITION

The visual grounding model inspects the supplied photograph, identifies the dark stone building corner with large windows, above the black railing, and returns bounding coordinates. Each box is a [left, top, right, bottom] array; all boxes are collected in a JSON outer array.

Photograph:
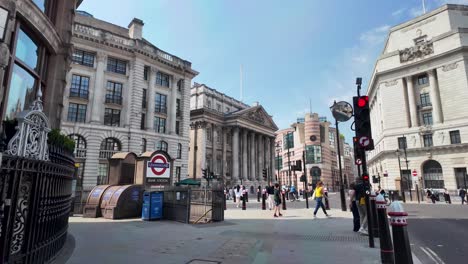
[[0, 0, 81, 128]]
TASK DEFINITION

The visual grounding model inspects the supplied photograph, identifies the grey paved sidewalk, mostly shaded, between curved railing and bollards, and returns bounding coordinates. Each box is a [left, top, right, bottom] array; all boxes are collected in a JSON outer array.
[[60, 208, 380, 264]]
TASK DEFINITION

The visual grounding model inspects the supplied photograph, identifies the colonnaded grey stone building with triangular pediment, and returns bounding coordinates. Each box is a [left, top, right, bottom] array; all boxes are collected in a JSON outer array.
[[189, 83, 278, 188]]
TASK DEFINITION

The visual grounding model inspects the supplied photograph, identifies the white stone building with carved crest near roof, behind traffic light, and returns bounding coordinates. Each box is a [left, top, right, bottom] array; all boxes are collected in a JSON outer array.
[[367, 5, 468, 191]]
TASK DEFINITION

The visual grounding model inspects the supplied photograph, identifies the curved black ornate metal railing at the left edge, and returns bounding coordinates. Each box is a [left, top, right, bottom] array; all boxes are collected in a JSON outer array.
[[0, 146, 75, 263]]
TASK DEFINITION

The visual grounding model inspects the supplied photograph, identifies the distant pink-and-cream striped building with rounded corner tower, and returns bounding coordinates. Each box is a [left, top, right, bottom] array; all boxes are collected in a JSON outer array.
[[275, 113, 354, 191]]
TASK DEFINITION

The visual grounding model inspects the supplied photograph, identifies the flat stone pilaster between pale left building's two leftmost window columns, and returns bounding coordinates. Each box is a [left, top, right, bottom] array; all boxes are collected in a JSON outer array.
[[91, 52, 106, 124]]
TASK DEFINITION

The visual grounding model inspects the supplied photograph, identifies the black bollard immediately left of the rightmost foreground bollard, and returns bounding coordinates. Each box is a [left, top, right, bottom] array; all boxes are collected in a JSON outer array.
[[375, 194, 395, 264]]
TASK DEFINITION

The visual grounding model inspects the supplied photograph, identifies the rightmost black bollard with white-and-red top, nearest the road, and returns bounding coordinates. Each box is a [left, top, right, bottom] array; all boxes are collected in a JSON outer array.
[[388, 201, 413, 264]]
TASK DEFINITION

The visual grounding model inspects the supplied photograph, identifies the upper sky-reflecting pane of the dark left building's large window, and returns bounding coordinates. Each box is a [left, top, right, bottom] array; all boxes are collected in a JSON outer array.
[[15, 30, 39, 71]]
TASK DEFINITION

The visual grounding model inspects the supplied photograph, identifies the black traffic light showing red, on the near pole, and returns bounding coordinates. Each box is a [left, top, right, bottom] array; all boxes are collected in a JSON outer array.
[[353, 96, 374, 150]]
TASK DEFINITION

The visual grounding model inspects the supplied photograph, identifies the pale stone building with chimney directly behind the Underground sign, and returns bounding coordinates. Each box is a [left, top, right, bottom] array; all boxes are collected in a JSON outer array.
[[61, 11, 198, 197]]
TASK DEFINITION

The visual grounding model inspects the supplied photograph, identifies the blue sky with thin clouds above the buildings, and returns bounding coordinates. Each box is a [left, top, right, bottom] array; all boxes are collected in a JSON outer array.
[[79, 0, 468, 143]]
